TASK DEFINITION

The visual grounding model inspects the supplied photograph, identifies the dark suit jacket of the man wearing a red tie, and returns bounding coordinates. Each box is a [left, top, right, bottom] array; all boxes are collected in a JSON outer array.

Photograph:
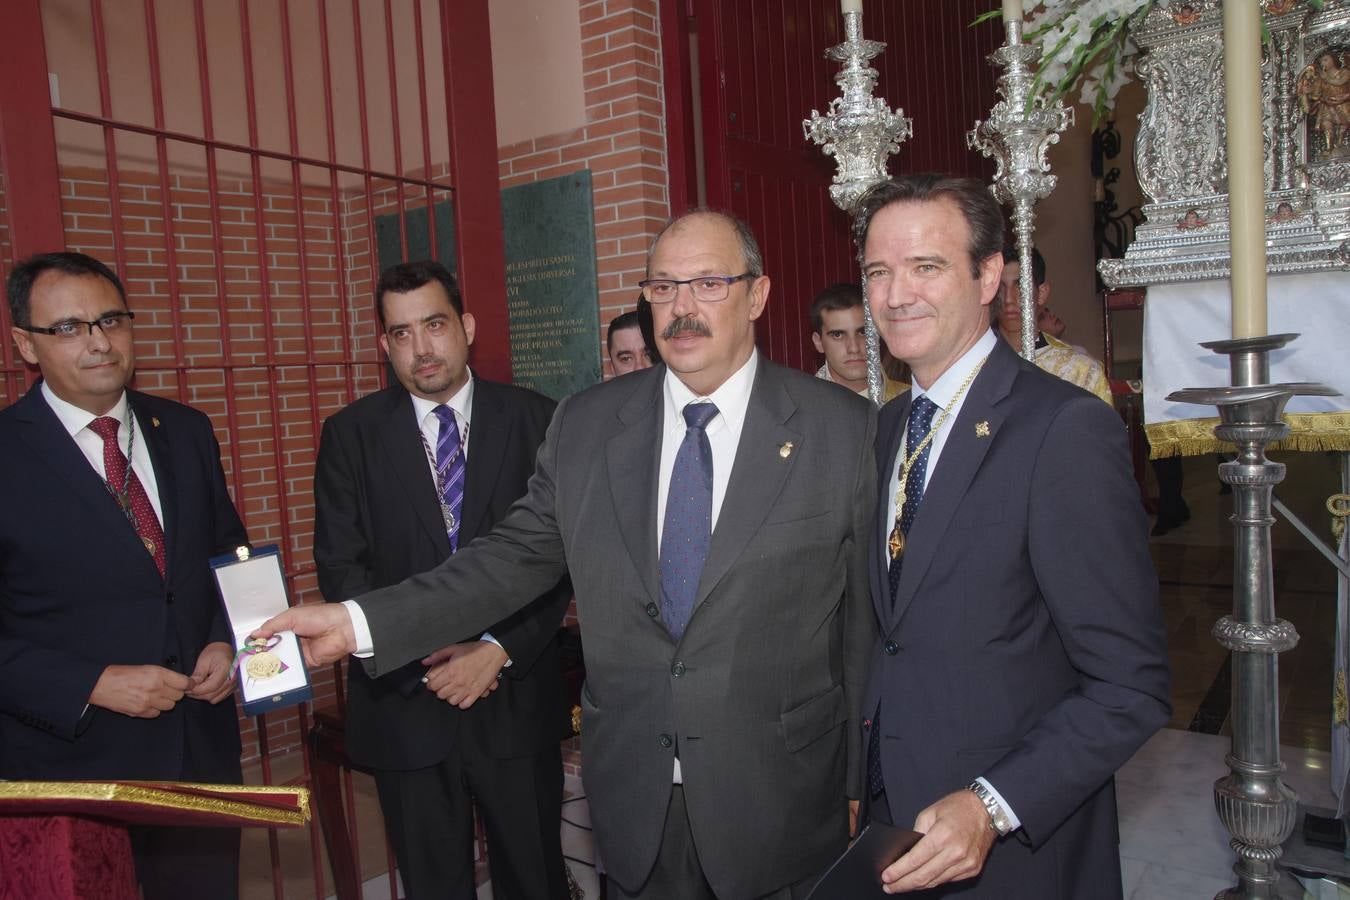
[[0, 385, 247, 783]]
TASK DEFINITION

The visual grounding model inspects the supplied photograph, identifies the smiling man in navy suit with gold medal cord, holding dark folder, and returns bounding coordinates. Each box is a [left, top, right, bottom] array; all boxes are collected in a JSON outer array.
[[859, 175, 1169, 900]]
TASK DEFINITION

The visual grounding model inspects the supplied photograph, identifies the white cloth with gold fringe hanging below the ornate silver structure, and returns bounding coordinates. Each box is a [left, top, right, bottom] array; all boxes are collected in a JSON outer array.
[[1143, 271, 1350, 459]]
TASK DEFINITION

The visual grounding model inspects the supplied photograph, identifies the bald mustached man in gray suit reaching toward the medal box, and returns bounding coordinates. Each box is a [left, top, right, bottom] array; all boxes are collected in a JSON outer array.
[[261, 212, 876, 900]]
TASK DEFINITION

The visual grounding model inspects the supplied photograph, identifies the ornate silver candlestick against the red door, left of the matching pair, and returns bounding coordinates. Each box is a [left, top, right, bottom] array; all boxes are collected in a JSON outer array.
[[802, 12, 914, 405]]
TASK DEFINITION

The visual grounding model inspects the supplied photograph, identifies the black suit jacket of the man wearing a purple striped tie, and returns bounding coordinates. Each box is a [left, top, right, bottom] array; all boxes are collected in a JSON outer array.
[[315, 378, 571, 769]]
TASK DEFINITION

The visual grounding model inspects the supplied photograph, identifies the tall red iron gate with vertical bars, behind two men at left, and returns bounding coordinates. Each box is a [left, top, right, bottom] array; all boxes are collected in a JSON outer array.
[[0, 0, 510, 897]]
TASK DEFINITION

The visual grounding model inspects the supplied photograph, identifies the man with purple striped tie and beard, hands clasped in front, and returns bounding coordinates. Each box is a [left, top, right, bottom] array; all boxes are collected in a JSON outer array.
[[315, 262, 571, 900]]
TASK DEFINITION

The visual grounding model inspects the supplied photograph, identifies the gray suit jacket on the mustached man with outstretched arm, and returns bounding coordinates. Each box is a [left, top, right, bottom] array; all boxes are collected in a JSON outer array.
[[358, 359, 876, 897]]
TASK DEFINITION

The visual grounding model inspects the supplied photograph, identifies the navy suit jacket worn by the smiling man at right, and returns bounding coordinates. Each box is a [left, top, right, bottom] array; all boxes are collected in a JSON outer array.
[[863, 341, 1170, 900]]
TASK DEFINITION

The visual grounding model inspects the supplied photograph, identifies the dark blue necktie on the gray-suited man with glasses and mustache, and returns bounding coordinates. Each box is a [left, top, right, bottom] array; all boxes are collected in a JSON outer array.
[[662, 403, 717, 641]]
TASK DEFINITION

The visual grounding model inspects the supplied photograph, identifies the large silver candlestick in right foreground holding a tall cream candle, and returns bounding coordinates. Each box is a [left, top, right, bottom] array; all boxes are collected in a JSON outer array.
[[1168, 335, 1338, 900]]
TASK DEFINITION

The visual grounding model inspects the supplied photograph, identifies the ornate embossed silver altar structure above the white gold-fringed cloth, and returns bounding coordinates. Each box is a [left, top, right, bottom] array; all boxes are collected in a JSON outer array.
[[1098, 0, 1350, 287]]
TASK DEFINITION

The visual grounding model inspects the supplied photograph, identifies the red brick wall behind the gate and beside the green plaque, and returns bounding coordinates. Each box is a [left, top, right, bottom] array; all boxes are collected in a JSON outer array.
[[0, 0, 670, 775]]
